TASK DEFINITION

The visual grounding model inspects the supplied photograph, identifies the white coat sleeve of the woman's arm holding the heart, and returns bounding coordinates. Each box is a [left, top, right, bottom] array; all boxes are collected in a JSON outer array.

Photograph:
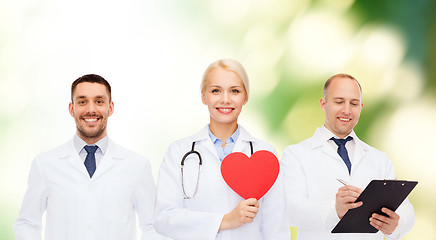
[[155, 143, 224, 240]]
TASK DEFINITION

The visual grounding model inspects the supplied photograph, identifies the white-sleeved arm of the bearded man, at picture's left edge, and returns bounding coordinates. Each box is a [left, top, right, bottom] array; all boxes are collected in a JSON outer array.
[[13, 159, 47, 240]]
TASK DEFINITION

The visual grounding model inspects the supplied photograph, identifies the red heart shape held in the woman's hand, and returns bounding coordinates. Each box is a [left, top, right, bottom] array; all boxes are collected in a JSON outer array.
[[221, 150, 280, 200]]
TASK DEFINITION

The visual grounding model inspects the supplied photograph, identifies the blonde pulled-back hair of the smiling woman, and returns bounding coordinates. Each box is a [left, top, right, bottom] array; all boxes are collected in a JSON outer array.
[[200, 58, 250, 99]]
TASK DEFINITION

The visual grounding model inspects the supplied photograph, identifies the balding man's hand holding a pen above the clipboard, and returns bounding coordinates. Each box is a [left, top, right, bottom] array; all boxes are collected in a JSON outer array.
[[335, 179, 363, 219]]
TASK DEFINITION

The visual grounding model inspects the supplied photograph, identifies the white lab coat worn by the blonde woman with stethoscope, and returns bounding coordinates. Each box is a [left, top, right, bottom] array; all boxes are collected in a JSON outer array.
[[154, 126, 290, 240]]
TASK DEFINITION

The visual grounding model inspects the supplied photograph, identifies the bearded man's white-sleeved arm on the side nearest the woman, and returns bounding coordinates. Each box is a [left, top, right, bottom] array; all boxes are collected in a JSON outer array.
[[133, 160, 164, 240]]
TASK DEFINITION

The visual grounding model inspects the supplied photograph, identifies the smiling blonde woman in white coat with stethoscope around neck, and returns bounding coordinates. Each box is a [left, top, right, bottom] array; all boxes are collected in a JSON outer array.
[[154, 59, 290, 240]]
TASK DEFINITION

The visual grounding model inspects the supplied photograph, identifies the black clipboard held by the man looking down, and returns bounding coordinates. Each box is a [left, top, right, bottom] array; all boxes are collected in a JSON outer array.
[[332, 180, 418, 233]]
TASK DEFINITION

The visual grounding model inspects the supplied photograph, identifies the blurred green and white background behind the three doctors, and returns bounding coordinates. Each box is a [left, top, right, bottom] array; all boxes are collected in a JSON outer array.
[[0, 0, 436, 240]]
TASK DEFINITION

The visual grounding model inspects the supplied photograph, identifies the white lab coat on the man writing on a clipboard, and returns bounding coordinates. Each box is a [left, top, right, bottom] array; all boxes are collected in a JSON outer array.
[[282, 128, 415, 240]]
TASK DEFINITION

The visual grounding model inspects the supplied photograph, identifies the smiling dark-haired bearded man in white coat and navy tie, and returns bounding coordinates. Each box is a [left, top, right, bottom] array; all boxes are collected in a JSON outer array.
[[14, 74, 163, 240]]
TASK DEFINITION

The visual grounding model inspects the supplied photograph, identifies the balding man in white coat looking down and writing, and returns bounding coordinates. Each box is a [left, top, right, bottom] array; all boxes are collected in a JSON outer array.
[[282, 74, 415, 240]]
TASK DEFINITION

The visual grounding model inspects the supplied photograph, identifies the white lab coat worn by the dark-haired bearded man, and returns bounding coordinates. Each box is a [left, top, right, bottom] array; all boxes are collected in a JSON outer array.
[[14, 137, 162, 240]]
